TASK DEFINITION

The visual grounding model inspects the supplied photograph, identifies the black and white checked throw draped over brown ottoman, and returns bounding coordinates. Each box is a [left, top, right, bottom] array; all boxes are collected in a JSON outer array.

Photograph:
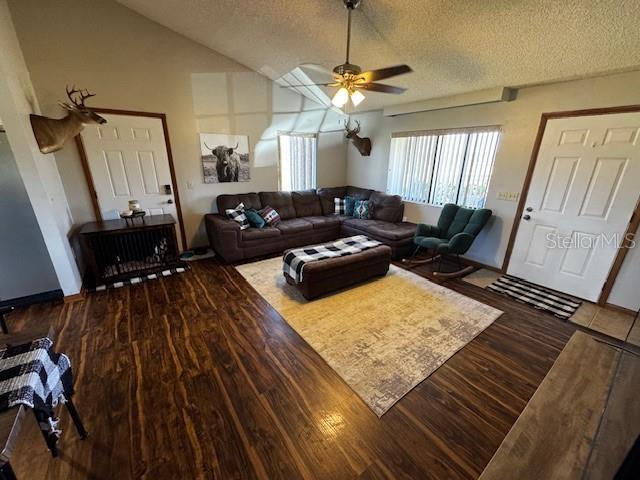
[[282, 235, 382, 283]]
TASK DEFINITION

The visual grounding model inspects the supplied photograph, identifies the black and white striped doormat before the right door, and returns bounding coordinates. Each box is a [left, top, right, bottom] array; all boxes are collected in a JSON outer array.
[[486, 275, 582, 320]]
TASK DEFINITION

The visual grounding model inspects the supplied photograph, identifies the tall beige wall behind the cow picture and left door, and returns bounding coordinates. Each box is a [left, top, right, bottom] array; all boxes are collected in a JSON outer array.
[[9, 0, 346, 246]]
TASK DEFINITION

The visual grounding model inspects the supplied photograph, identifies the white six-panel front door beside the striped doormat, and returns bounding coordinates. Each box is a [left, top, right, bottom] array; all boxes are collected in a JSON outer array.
[[507, 113, 640, 301]]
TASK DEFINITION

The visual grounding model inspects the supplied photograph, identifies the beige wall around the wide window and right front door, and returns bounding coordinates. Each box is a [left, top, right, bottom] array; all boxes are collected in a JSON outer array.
[[347, 72, 640, 309]]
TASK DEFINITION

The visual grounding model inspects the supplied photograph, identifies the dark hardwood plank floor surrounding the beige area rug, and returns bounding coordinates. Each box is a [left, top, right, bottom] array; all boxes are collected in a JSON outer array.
[[9, 260, 574, 480]]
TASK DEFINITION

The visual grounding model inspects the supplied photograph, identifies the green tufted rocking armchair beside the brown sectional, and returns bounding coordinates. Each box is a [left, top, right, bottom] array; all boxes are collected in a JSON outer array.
[[406, 203, 492, 276]]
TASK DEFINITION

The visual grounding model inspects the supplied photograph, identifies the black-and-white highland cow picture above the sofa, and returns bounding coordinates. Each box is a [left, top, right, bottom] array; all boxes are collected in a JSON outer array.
[[200, 133, 251, 183]]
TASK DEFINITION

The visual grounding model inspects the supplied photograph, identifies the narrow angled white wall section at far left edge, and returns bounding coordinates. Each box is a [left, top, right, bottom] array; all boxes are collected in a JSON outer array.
[[0, 0, 82, 295]]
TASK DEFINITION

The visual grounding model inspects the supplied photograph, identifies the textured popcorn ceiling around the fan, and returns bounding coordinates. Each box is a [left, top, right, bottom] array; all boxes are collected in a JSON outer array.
[[118, 0, 640, 110]]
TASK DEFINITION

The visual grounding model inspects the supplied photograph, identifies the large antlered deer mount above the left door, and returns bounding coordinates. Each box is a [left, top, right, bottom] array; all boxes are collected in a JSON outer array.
[[30, 86, 107, 153]]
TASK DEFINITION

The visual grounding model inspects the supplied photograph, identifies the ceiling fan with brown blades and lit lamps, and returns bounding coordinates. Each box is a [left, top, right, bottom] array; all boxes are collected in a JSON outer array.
[[294, 0, 413, 108]]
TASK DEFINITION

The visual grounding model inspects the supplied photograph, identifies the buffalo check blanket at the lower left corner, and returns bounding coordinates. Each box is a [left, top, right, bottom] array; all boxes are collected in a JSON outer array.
[[0, 338, 73, 416]]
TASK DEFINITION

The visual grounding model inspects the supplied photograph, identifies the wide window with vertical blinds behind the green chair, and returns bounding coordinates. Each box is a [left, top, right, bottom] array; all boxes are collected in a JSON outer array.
[[387, 127, 500, 208]]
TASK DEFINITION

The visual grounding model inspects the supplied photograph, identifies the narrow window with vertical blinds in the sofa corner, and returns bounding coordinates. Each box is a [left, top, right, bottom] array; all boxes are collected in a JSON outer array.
[[278, 133, 317, 191]]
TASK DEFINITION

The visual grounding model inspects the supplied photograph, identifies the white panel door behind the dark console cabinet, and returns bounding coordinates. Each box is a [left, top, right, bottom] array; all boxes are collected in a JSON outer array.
[[81, 114, 180, 248]]
